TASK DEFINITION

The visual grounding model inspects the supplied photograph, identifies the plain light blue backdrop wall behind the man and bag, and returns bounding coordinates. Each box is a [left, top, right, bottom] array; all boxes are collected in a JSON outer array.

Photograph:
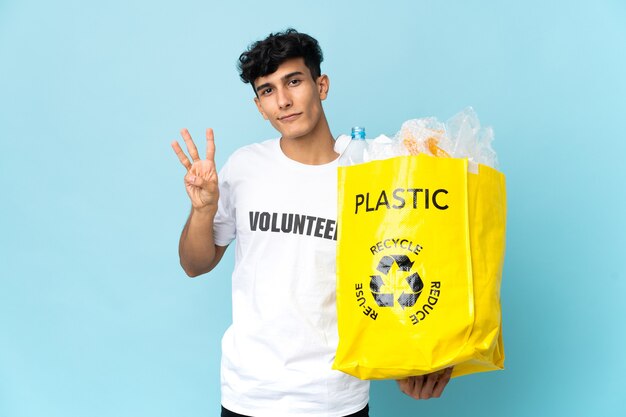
[[0, 0, 626, 417]]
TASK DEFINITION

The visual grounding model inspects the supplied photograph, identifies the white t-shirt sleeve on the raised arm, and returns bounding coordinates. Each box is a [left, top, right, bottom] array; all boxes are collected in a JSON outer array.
[[213, 159, 237, 246]]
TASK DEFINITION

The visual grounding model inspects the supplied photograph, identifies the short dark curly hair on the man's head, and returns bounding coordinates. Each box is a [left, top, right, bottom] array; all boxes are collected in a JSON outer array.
[[238, 28, 324, 94]]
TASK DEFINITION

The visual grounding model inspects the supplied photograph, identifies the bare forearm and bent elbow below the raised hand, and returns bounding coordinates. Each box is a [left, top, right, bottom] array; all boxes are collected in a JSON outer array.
[[178, 208, 227, 277]]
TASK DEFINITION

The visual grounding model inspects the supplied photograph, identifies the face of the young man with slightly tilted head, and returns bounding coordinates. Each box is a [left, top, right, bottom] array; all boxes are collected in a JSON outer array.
[[254, 58, 329, 139]]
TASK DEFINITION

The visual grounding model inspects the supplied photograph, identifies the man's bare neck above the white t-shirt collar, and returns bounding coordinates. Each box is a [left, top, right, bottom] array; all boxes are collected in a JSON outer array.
[[280, 116, 339, 165]]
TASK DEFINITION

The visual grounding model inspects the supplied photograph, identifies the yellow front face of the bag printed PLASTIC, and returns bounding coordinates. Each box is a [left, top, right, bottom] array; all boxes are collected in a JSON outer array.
[[333, 155, 474, 379]]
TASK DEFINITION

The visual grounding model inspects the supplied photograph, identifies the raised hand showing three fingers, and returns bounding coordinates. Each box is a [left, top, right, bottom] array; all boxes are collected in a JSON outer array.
[[172, 128, 219, 214]]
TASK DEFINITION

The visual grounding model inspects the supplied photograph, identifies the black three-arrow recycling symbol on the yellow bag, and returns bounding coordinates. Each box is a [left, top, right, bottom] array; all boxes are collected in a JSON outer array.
[[370, 255, 424, 309]]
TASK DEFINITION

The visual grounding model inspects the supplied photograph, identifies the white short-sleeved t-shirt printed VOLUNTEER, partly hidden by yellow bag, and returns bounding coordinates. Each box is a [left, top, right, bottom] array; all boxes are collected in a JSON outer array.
[[214, 139, 369, 417]]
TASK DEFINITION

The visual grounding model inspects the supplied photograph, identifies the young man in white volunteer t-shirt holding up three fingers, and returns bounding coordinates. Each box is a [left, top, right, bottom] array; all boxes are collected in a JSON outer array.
[[172, 29, 450, 417]]
